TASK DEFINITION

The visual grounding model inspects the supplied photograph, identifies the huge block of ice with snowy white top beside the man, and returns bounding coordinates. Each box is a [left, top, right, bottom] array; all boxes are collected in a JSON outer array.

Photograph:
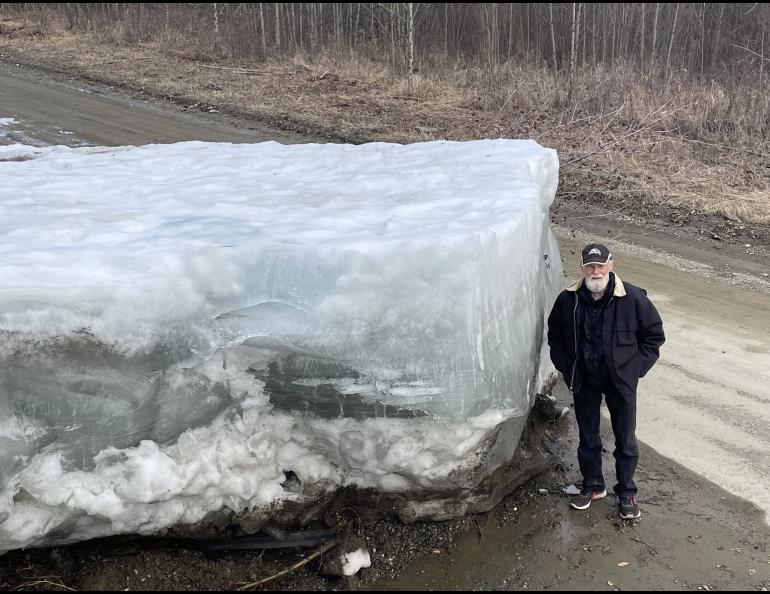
[[0, 140, 561, 550]]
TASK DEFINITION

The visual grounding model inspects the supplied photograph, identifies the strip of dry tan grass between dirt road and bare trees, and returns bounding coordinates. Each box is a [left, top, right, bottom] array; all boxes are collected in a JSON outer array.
[[0, 17, 770, 232]]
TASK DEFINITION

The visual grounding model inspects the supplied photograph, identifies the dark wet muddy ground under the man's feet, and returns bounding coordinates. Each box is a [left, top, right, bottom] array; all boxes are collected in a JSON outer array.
[[371, 386, 770, 590]]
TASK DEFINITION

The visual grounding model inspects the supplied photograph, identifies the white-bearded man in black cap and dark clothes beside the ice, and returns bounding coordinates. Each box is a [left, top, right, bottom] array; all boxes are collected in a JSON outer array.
[[548, 243, 665, 520]]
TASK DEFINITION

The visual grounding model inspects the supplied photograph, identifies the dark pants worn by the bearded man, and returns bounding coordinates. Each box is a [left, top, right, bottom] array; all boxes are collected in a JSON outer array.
[[575, 381, 639, 497]]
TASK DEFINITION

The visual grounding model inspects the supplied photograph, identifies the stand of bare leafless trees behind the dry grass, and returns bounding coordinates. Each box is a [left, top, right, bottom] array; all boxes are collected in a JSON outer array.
[[7, 2, 770, 102]]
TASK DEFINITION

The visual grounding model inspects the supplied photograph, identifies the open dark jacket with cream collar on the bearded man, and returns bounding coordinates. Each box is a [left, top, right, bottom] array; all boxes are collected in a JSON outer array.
[[548, 272, 666, 396]]
